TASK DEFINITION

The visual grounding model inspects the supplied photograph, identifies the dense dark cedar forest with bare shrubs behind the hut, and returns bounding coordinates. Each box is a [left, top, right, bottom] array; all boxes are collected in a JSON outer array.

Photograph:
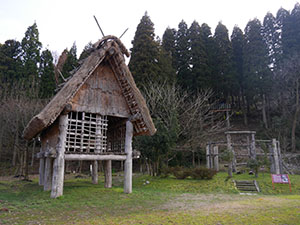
[[0, 4, 300, 176]]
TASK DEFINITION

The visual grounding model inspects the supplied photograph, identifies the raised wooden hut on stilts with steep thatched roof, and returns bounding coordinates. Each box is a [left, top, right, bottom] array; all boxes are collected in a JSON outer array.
[[23, 36, 156, 198]]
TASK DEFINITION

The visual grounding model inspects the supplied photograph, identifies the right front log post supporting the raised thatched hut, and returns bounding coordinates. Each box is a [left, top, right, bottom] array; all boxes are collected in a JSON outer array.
[[124, 120, 133, 194]]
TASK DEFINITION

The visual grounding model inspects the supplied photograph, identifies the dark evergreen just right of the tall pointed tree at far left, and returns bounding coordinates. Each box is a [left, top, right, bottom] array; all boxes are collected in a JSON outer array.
[[39, 49, 56, 98]]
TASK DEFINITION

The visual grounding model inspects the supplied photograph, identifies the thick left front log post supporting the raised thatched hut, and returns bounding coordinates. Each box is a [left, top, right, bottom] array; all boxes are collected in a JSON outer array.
[[51, 114, 68, 198]]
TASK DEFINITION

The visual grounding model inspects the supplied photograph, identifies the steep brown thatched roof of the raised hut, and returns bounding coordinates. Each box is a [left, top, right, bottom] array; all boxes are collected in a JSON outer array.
[[23, 36, 156, 140]]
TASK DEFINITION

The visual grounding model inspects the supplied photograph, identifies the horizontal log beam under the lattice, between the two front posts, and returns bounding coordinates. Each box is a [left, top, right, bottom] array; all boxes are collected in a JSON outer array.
[[65, 153, 126, 161]]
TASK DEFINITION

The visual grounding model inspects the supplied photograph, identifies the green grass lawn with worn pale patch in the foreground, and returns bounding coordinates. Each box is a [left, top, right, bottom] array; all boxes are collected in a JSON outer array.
[[0, 173, 300, 224]]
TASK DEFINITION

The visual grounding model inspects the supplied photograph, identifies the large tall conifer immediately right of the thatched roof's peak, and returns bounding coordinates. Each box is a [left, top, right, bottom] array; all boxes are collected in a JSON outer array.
[[129, 12, 162, 88]]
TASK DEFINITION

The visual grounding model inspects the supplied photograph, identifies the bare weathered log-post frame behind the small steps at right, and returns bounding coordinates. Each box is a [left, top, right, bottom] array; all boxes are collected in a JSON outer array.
[[206, 131, 283, 174]]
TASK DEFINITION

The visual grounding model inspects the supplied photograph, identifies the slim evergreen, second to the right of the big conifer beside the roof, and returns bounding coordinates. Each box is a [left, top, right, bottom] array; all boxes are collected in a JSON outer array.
[[175, 20, 192, 89]]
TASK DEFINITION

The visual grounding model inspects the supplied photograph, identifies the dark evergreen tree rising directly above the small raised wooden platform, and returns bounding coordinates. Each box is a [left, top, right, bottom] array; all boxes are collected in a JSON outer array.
[[213, 22, 236, 99]]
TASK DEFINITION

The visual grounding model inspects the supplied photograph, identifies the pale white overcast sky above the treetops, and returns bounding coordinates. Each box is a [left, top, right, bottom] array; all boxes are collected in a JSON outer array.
[[0, 0, 297, 58]]
